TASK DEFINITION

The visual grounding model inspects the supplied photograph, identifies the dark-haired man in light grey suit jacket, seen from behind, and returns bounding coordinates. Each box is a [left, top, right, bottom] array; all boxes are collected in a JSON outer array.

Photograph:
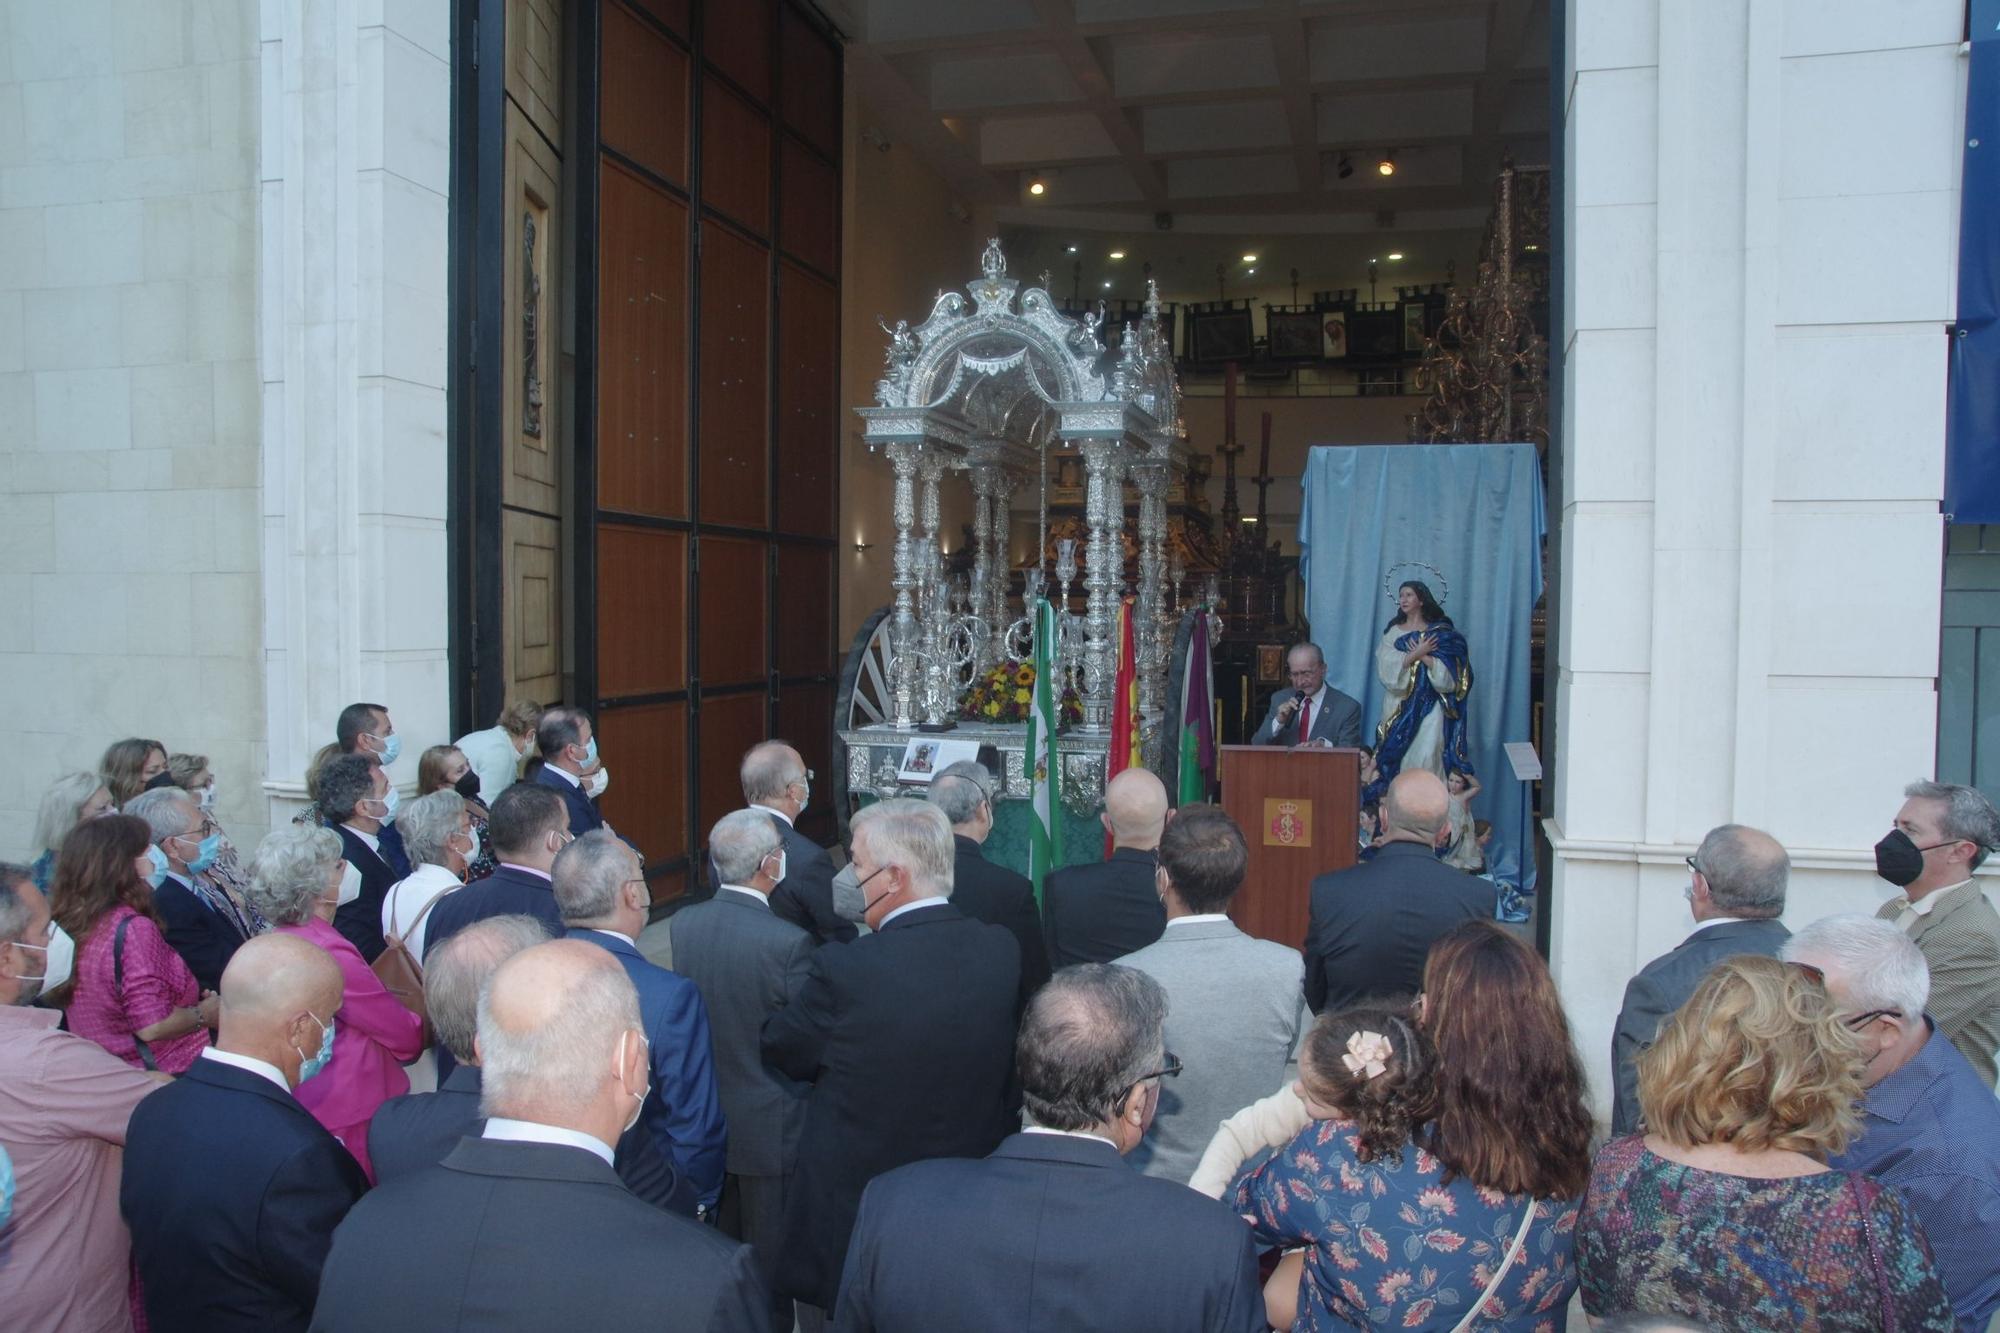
[[1118, 805, 1306, 1183]]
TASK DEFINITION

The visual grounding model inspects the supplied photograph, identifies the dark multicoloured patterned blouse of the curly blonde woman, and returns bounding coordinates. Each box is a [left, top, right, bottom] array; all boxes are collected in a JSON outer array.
[[1576, 1135, 1954, 1333]]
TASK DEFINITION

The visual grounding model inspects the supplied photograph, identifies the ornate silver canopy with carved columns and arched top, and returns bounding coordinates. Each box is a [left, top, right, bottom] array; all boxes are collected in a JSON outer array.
[[840, 238, 1188, 813]]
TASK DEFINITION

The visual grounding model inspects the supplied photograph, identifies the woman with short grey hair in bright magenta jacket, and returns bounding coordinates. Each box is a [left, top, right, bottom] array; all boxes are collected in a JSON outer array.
[[250, 825, 424, 1181]]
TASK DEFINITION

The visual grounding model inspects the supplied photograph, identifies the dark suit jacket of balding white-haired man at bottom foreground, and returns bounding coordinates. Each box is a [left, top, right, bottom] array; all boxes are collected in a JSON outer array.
[[312, 1139, 770, 1333]]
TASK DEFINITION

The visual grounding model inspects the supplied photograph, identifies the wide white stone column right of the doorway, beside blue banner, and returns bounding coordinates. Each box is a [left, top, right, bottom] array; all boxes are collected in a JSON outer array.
[[1548, 0, 1964, 1115]]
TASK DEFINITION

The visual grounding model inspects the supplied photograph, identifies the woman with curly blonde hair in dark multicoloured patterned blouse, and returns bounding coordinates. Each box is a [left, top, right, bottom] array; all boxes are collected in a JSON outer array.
[[1576, 955, 1954, 1331]]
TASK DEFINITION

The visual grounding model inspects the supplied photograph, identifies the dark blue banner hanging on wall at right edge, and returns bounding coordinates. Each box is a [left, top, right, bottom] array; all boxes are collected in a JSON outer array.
[[1944, 0, 2000, 522]]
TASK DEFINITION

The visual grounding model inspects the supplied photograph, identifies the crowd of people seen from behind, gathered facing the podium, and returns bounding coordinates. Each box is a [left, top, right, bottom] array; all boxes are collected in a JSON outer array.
[[0, 700, 2000, 1333]]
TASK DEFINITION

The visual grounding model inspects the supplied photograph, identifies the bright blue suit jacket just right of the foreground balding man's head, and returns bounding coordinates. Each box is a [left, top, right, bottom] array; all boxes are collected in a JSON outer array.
[[568, 927, 730, 1207]]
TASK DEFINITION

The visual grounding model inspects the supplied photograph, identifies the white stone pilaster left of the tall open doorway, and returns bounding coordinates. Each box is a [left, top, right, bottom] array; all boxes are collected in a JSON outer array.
[[258, 0, 452, 825]]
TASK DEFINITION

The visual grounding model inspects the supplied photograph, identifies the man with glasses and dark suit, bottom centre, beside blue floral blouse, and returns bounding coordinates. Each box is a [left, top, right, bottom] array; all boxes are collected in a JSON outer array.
[[834, 965, 1266, 1333]]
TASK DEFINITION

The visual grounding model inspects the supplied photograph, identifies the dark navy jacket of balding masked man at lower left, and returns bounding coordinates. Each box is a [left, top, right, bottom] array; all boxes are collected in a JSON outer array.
[[118, 1057, 368, 1333]]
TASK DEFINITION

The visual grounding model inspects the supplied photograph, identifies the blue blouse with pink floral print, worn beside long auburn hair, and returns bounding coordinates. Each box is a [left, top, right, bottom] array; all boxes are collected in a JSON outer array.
[[1232, 1121, 1580, 1333]]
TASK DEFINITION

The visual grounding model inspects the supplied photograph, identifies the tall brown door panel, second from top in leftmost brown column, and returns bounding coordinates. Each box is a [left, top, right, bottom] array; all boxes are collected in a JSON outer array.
[[598, 160, 688, 518]]
